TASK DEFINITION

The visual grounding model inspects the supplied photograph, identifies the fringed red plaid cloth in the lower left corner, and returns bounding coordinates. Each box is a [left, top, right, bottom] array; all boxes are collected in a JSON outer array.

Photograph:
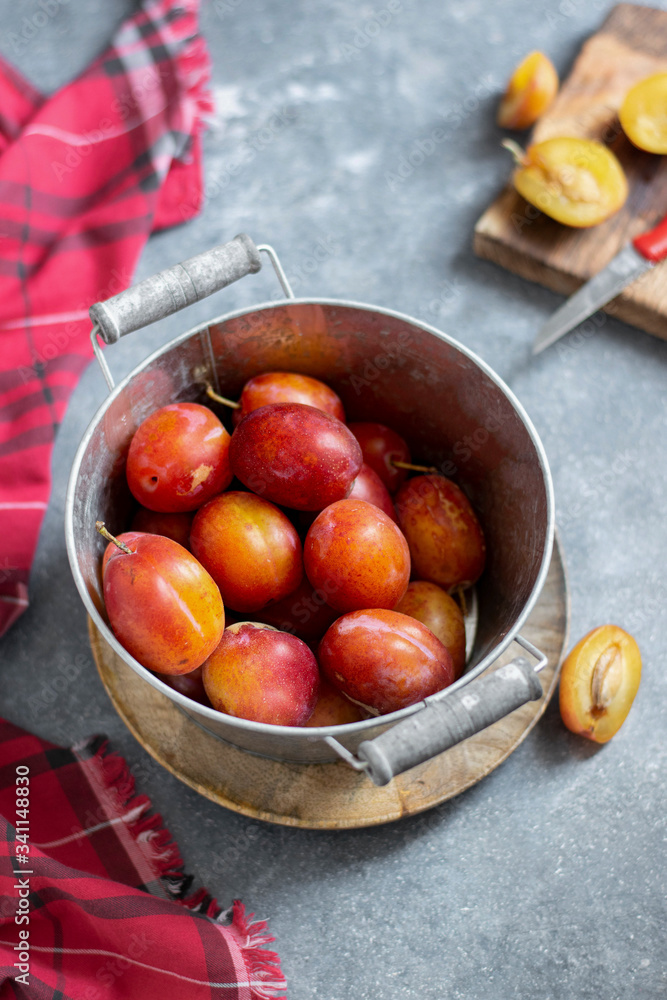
[[0, 720, 285, 1000]]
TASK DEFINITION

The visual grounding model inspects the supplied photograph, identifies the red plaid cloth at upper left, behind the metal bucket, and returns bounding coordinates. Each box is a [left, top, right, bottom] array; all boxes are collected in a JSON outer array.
[[0, 0, 210, 634]]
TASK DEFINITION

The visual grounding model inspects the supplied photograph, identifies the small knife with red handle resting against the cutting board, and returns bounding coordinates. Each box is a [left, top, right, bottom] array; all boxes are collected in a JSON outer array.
[[533, 215, 667, 354]]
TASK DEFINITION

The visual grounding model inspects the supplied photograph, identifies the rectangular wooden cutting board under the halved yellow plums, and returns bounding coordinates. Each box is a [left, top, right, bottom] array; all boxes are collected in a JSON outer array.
[[474, 3, 667, 339]]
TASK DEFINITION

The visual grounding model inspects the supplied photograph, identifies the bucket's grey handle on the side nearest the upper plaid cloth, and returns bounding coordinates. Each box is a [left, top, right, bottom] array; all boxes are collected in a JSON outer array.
[[89, 233, 294, 389]]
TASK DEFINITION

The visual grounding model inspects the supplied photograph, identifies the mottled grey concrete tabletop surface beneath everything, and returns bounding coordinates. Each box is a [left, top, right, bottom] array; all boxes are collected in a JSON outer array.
[[0, 0, 667, 1000]]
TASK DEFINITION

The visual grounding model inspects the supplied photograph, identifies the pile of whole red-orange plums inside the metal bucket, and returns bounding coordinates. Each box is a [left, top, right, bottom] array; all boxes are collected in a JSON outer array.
[[97, 372, 486, 726]]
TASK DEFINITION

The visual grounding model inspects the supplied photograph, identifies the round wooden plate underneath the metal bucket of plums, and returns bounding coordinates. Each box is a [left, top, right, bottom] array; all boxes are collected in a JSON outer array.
[[89, 542, 569, 830]]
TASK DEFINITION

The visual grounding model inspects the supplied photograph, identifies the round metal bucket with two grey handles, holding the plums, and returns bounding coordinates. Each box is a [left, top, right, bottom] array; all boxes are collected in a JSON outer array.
[[66, 237, 553, 784]]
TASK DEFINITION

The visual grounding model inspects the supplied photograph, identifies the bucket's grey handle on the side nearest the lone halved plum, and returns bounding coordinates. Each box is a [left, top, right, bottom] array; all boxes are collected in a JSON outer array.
[[325, 635, 547, 785]]
